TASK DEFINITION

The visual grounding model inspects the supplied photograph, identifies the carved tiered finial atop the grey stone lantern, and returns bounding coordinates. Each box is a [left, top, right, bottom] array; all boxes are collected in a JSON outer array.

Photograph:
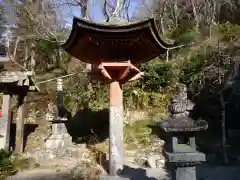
[[169, 84, 194, 118]]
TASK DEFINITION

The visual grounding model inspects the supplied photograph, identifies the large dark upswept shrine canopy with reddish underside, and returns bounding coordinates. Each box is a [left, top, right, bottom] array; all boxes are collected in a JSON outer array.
[[62, 17, 172, 64]]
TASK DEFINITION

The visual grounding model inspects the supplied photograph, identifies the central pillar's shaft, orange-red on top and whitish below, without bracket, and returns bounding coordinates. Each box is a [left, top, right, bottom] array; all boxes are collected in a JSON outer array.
[[109, 81, 124, 176]]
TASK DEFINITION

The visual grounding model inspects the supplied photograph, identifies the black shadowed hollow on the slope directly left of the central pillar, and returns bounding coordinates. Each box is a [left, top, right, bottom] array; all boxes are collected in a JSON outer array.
[[66, 108, 109, 144]]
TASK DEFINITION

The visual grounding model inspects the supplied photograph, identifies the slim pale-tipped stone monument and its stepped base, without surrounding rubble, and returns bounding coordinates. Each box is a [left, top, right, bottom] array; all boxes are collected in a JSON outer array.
[[46, 79, 72, 154]]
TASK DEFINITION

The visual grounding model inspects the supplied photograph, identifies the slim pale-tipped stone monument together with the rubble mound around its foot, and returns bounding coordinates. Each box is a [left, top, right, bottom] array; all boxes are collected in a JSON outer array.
[[27, 79, 76, 164]]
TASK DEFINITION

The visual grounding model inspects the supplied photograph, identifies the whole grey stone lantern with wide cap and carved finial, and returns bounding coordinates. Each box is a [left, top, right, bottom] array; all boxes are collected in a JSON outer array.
[[160, 84, 208, 180]]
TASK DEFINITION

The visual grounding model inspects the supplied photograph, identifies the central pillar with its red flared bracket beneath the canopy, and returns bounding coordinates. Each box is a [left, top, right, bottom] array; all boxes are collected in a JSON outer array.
[[92, 61, 142, 178]]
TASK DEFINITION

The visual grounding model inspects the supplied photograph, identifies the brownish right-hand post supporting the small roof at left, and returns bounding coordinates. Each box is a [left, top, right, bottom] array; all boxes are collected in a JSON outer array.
[[15, 94, 26, 153]]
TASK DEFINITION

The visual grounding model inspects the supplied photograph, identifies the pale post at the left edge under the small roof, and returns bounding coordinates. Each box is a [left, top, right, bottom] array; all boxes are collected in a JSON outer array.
[[0, 93, 12, 151]]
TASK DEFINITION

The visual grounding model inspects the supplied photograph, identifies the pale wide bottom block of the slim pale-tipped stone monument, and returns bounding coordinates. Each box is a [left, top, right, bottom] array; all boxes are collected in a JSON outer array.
[[46, 133, 72, 150]]
